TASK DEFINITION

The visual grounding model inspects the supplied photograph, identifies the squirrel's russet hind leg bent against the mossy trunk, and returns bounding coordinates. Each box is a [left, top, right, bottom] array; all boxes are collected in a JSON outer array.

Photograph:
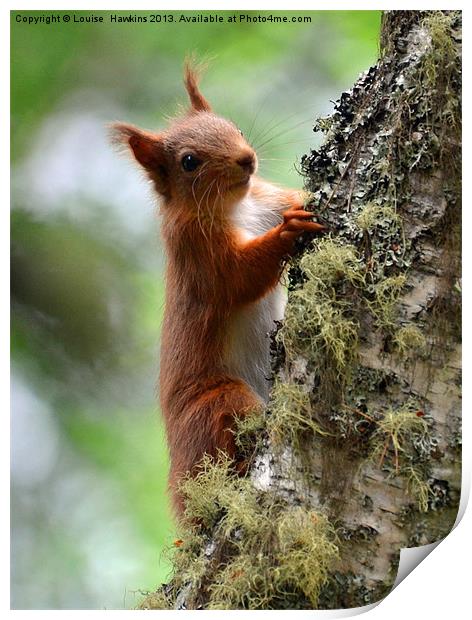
[[169, 377, 263, 518]]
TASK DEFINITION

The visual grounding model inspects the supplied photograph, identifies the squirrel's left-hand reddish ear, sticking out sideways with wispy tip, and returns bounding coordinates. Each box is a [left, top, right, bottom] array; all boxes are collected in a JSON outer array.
[[111, 123, 168, 194]]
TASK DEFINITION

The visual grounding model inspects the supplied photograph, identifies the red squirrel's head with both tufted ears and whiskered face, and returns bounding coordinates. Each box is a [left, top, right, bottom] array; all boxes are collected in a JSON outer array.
[[113, 62, 257, 220]]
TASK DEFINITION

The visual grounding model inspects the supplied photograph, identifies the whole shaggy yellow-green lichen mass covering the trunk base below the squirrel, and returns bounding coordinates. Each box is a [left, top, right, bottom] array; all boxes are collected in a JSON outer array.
[[151, 455, 338, 609]]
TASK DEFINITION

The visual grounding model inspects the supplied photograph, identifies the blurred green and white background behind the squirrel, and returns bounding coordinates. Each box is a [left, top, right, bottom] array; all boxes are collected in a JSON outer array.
[[11, 11, 380, 609]]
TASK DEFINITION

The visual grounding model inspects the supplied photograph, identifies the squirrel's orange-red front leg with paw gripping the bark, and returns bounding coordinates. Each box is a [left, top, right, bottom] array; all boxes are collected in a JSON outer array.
[[231, 207, 325, 305]]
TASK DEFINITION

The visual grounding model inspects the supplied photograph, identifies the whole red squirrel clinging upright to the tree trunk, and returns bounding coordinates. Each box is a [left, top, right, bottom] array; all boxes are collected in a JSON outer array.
[[113, 63, 324, 516]]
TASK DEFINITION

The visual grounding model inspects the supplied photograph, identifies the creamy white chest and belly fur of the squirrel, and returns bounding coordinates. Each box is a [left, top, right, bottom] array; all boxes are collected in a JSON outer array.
[[225, 191, 286, 401]]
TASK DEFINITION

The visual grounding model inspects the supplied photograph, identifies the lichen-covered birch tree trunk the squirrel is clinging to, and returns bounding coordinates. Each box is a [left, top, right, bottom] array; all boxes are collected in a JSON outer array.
[[142, 11, 461, 609]]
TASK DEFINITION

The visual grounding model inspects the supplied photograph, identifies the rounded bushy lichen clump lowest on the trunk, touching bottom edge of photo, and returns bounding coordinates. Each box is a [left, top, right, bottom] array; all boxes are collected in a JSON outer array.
[[208, 505, 338, 609]]
